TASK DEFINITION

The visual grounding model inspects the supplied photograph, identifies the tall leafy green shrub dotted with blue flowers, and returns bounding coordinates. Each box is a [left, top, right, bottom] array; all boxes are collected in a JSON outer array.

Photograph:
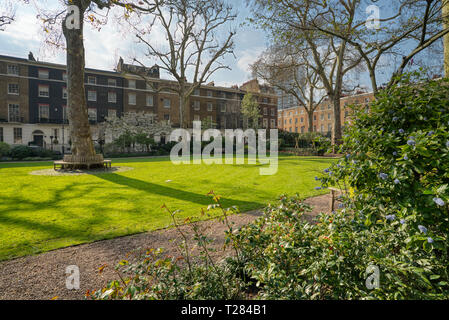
[[322, 75, 449, 254]]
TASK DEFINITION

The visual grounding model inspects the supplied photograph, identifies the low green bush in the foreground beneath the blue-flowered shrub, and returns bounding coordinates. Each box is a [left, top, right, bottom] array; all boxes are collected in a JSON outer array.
[[233, 197, 449, 299]]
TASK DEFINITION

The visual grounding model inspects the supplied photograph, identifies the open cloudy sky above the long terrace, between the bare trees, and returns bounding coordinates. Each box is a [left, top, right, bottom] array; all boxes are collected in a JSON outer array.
[[0, 0, 268, 87]]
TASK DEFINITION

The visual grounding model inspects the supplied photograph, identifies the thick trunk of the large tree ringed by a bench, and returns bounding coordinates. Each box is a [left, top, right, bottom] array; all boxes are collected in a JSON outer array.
[[62, 0, 95, 156]]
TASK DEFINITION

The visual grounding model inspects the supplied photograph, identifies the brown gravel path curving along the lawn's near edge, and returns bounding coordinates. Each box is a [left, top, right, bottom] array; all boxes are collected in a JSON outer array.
[[0, 195, 329, 300]]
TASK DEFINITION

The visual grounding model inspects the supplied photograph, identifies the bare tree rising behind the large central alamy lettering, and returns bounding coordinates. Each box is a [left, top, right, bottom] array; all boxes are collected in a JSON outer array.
[[131, 0, 236, 127]]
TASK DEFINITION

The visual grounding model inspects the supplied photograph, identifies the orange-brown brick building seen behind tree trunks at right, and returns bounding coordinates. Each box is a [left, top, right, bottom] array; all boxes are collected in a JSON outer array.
[[278, 93, 374, 135]]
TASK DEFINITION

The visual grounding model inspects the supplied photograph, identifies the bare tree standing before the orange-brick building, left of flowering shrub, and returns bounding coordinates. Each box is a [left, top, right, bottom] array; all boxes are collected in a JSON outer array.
[[250, 0, 362, 145]]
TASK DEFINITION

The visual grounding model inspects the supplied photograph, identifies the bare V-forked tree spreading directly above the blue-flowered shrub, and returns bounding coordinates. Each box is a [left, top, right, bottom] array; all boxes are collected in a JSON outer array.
[[282, 0, 449, 94]]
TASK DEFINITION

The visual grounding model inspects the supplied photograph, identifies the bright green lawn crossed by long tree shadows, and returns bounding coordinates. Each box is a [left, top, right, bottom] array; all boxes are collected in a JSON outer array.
[[0, 156, 333, 260]]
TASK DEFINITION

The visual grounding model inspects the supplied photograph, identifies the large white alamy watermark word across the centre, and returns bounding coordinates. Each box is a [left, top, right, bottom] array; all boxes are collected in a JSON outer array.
[[170, 121, 278, 175]]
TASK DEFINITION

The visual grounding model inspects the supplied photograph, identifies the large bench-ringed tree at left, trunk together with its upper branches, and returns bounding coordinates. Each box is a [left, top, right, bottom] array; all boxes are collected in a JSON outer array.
[[33, 0, 156, 157]]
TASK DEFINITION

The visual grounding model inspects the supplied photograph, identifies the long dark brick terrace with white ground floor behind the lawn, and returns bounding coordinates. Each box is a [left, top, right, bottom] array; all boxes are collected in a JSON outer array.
[[0, 53, 278, 151]]
